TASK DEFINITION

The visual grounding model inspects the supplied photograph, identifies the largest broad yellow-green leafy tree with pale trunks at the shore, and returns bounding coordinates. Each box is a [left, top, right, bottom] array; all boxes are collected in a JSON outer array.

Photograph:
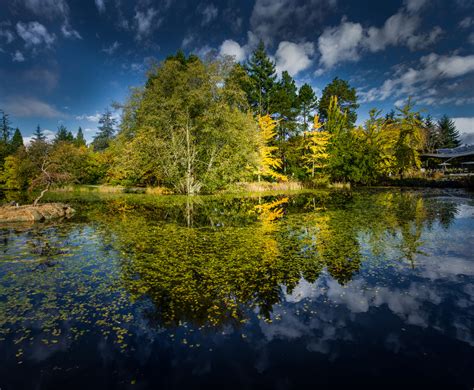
[[109, 54, 257, 195]]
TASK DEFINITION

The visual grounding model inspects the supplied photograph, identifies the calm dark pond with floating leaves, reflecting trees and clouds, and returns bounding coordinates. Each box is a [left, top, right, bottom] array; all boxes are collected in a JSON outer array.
[[0, 189, 474, 390]]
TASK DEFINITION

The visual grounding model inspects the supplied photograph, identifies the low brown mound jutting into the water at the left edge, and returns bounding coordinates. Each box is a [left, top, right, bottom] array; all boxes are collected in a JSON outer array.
[[0, 203, 75, 223]]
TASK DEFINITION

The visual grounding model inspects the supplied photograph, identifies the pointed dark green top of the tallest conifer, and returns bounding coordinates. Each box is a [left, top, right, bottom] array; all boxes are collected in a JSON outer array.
[[246, 41, 276, 116]]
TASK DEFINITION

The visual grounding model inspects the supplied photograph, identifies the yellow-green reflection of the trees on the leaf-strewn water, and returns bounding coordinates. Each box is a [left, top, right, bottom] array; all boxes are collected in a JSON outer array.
[[112, 192, 462, 326]]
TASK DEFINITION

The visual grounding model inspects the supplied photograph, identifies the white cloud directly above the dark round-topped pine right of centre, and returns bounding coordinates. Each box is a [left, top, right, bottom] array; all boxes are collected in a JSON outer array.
[[318, 20, 363, 68]]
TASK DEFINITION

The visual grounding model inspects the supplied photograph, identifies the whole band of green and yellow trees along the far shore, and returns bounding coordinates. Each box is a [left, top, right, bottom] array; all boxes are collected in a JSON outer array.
[[0, 43, 460, 194]]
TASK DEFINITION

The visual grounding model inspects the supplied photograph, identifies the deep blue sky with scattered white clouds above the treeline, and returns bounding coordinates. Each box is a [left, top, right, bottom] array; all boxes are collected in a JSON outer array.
[[0, 0, 474, 143]]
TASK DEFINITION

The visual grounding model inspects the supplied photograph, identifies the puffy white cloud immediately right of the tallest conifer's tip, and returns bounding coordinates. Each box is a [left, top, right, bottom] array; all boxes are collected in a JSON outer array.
[[275, 41, 314, 76]]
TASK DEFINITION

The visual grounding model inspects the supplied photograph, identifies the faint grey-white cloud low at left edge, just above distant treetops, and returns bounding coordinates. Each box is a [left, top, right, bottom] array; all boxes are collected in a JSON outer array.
[[2, 96, 65, 118]]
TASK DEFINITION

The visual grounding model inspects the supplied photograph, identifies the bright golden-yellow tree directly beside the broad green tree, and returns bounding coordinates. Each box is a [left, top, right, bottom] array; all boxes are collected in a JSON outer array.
[[256, 114, 287, 181]]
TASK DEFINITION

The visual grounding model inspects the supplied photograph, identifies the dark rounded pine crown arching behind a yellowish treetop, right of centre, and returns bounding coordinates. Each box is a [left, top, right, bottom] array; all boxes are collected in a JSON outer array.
[[318, 77, 359, 127]]
